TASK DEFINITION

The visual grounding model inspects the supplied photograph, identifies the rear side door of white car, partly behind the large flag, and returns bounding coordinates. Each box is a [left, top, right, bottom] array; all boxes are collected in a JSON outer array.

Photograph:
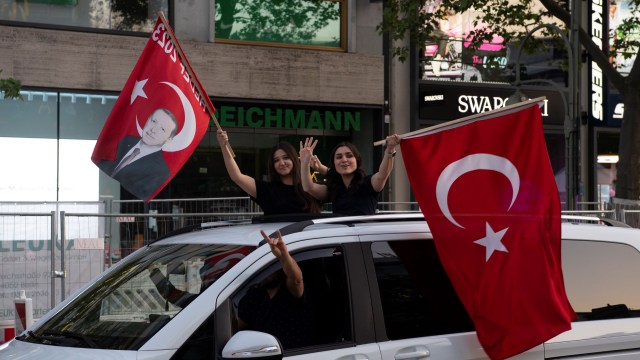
[[361, 234, 544, 360]]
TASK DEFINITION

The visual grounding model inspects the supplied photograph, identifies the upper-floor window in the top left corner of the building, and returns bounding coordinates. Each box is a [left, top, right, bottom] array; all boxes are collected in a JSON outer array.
[[0, 0, 169, 32]]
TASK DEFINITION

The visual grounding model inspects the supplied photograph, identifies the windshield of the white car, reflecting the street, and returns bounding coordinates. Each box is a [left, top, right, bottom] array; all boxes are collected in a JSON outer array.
[[18, 244, 255, 350]]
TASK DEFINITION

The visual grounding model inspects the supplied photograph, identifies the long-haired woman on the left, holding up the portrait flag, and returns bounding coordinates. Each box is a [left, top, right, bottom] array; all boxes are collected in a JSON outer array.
[[217, 130, 320, 215]]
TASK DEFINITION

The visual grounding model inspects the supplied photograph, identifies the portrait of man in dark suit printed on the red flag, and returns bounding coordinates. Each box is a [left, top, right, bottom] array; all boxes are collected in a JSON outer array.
[[98, 108, 178, 200]]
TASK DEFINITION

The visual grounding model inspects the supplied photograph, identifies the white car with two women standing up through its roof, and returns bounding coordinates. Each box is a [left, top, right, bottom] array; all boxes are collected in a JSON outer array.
[[0, 214, 640, 360]]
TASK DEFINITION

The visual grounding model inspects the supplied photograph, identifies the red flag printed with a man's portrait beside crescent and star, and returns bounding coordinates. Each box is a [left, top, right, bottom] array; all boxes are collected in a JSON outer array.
[[91, 17, 215, 201]]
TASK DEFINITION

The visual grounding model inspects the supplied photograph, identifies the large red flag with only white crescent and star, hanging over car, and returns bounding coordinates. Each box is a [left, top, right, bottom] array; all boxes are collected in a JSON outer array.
[[400, 102, 575, 359]]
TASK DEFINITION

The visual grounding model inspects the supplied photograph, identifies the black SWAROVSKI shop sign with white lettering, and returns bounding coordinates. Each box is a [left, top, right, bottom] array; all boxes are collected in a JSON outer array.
[[418, 83, 566, 125]]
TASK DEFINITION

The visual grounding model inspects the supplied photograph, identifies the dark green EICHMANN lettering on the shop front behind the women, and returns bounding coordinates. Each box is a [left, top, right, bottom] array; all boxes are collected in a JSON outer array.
[[217, 106, 360, 131]]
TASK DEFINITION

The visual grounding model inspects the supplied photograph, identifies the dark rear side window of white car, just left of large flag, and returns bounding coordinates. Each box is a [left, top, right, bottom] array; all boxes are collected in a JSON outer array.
[[371, 240, 474, 340]]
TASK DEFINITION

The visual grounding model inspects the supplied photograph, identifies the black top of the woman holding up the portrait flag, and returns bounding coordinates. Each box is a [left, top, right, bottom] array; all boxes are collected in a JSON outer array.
[[251, 180, 309, 215]]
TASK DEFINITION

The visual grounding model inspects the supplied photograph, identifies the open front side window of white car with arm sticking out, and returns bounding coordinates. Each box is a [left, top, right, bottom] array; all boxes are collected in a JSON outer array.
[[232, 247, 352, 353]]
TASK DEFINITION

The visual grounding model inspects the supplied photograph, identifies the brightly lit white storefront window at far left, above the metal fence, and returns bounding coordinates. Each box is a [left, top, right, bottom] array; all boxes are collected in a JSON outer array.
[[0, 90, 119, 201]]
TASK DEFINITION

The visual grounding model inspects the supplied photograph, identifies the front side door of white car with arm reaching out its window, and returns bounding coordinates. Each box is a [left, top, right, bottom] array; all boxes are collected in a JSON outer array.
[[218, 237, 381, 360]]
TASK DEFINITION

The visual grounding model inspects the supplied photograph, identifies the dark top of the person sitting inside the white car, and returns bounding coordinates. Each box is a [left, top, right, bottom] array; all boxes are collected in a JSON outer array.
[[238, 284, 315, 349]]
